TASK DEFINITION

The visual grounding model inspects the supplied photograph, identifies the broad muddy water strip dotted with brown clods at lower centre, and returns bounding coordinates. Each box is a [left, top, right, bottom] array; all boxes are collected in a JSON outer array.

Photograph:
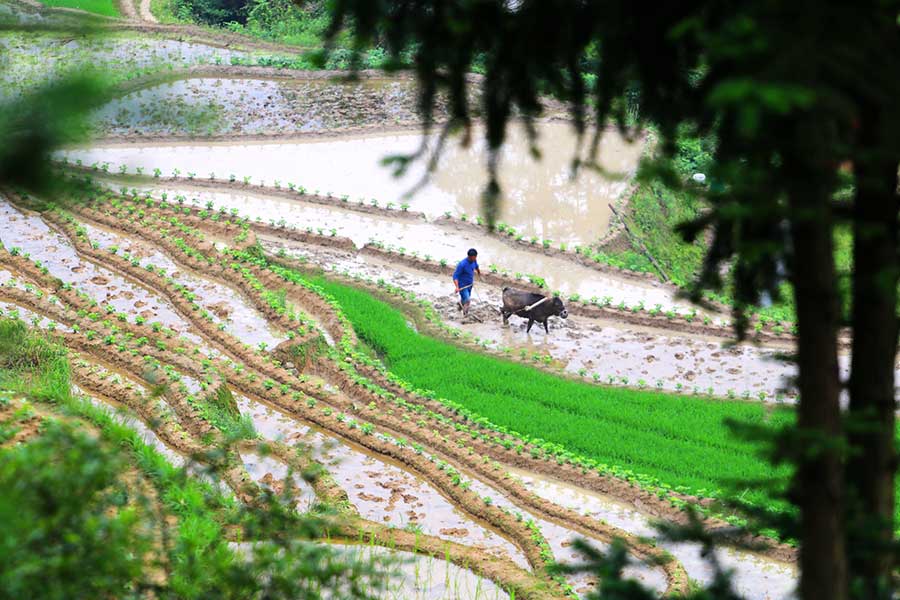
[[238, 397, 528, 568]]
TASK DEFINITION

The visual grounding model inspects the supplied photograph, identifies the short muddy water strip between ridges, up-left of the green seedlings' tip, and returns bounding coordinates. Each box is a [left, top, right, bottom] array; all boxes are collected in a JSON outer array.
[[81, 222, 287, 348]]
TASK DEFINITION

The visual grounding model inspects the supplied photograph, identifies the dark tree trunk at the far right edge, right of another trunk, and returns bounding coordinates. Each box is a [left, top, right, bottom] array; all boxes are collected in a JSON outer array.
[[847, 111, 900, 599]]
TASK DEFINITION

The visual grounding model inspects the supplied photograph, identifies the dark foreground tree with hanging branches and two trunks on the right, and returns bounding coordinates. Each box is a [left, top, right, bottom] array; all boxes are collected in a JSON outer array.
[[322, 0, 900, 600]]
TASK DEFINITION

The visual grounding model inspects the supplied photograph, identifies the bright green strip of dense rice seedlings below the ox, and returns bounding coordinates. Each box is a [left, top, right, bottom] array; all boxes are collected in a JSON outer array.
[[304, 278, 793, 504]]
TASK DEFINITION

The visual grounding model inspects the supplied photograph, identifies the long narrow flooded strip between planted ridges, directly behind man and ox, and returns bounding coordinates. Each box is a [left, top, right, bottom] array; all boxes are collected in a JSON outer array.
[[109, 186, 691, 313]]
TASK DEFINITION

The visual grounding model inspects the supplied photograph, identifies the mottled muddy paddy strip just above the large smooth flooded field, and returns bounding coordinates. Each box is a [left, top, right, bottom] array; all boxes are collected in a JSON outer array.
[[94, 77, 419, 135]]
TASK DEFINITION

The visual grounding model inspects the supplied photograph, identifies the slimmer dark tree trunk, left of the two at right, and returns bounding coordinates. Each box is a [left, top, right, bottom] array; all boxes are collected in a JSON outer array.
[[789, 169, 847, 600]]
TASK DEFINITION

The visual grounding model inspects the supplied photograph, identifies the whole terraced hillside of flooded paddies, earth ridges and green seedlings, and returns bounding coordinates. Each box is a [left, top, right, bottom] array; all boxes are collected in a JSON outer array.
[[0, 0, 816, 599]]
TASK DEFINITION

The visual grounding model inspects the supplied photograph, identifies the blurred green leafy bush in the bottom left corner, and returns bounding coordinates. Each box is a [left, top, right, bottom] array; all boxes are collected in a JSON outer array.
[[0, 424, 151, 600]]
